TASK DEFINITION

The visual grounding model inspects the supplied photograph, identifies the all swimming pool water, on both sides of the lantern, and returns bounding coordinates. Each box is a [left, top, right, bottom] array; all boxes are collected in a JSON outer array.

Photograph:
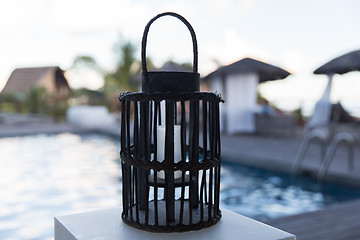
[[0, 133, 360, 240]]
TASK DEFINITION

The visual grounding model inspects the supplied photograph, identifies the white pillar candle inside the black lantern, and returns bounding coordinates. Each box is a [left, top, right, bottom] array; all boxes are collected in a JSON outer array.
[[157, 125, 181, 179]]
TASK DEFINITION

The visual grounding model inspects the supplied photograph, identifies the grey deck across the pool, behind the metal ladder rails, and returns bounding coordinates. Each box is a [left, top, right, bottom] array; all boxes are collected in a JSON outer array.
[[221, 133, 360, 187]]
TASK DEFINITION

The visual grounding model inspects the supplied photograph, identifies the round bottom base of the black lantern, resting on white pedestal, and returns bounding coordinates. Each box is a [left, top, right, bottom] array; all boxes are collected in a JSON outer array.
[[122, 200, 221, 232]]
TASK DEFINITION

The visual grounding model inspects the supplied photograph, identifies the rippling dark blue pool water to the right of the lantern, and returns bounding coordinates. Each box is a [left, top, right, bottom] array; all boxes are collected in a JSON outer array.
[[221, 161, 360, 220]]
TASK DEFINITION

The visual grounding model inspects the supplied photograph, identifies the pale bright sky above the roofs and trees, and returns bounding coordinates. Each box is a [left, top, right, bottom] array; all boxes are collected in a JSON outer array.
[[0, 0, 360, 114]]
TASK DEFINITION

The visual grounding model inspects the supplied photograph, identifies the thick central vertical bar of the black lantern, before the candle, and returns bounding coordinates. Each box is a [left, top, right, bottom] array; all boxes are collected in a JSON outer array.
[[164, 101, 175, 224]]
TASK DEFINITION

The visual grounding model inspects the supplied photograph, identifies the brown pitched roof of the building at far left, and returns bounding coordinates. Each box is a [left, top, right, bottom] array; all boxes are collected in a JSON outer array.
[[2, 66, 69, 93]]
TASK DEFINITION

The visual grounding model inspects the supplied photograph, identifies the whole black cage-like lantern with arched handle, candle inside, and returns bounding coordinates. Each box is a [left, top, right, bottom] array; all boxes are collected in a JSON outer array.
[[119, 12, 222, 232]]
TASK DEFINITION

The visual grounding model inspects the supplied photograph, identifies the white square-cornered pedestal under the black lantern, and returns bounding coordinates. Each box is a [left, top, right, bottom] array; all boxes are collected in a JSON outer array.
[[54, 208, 296, 240]]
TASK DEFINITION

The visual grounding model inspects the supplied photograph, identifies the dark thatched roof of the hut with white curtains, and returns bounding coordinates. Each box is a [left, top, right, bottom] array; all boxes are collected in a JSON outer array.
[[204, 58, 290, 82]]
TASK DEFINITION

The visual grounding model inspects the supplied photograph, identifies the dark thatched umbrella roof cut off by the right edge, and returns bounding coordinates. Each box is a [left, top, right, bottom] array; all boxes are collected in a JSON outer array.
[[314, 50, 360, 74]]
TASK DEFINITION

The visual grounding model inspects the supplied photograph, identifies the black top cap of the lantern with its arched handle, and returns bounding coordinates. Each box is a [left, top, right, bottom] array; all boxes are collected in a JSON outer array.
[[141, 12, 200, 93]]
